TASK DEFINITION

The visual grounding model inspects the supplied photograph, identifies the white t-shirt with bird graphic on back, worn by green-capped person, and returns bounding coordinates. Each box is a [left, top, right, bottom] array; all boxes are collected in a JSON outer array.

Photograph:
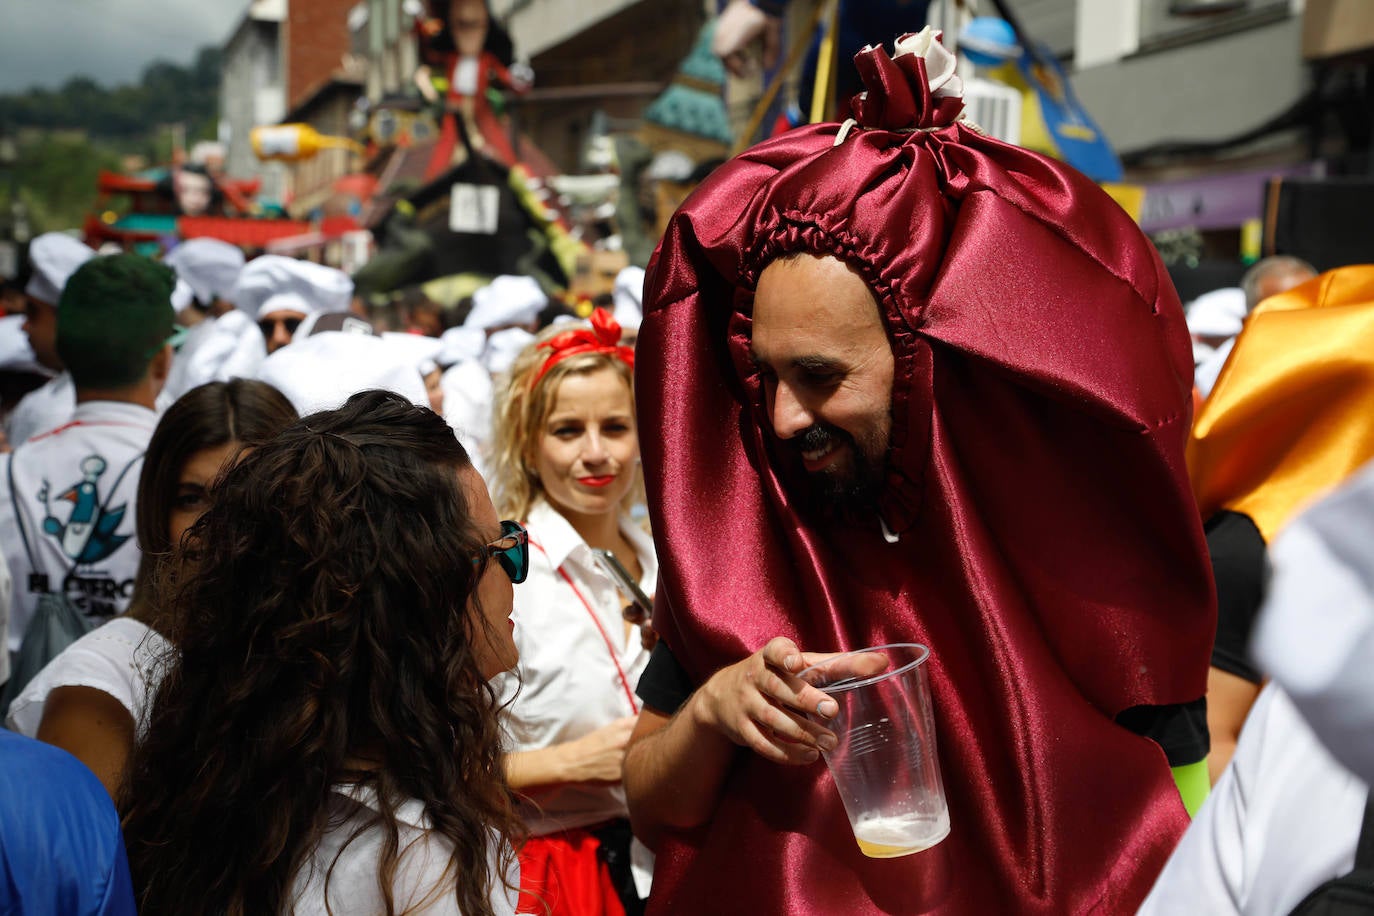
[[0, 401, 158, 650]]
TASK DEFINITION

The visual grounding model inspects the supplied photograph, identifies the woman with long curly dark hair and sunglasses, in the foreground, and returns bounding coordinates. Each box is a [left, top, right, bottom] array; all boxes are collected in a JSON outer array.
[[124, 391, 528, 916]]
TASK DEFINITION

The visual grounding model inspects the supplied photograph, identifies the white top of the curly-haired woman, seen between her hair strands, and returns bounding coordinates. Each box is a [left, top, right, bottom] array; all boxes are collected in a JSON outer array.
[[291, 786, 519, 916]]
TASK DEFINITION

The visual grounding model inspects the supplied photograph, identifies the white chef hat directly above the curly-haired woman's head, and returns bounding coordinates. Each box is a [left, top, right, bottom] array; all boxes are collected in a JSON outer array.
[[257, 331, 429, 416]]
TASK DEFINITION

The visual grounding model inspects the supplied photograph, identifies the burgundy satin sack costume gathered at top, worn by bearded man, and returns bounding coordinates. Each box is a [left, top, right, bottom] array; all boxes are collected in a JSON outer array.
[[636, 37, 1215, 916]]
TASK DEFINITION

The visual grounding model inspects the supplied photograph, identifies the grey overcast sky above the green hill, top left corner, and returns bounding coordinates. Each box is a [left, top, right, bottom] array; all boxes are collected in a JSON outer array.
[[0, 0, 249, 92]]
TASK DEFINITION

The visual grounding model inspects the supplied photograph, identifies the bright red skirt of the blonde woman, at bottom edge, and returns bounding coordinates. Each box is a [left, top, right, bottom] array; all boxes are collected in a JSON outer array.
[[515, 829, 625, 916]]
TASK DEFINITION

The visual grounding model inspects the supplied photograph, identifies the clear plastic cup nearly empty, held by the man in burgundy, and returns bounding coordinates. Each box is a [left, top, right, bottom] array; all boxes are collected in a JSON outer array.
[[798, 643, 949, 858]]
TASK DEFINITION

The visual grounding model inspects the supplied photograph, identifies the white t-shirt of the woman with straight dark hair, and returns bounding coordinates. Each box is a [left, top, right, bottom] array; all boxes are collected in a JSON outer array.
[[4, 617, 172, 737]]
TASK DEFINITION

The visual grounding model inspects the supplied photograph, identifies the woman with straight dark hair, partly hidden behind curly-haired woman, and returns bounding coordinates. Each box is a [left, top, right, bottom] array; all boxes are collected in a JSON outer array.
[[5, 379, 295, 797]]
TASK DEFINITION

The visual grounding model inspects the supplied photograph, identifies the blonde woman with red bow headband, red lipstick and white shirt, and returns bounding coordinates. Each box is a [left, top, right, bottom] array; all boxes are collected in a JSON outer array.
[[491, 309, 658, 916]]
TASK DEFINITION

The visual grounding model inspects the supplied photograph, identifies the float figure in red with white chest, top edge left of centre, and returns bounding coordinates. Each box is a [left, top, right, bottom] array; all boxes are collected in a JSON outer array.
[[415, 0, 529, 180]]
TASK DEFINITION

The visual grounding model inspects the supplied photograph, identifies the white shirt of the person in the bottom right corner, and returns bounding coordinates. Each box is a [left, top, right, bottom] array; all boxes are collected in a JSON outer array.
[[1139, 684, 1369, 916]]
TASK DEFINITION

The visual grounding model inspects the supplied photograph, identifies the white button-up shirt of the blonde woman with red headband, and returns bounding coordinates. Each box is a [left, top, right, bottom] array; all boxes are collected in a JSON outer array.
[[497, 503, 658, 836]]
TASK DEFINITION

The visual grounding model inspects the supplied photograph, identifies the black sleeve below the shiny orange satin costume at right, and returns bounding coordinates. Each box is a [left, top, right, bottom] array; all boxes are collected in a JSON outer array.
[[1204, 511, 1267, 684]]
